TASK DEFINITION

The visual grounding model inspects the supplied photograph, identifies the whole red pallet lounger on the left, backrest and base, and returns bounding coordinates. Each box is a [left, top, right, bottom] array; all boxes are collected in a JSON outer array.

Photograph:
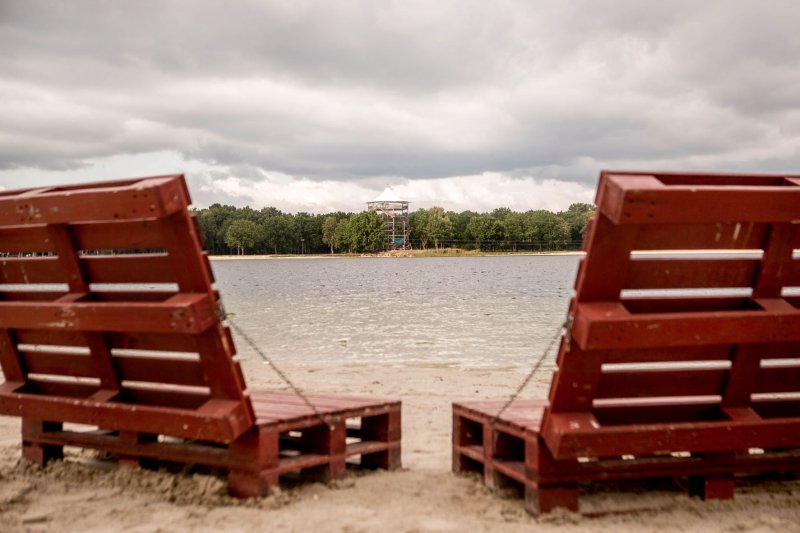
[[0, 175, 400, 497]]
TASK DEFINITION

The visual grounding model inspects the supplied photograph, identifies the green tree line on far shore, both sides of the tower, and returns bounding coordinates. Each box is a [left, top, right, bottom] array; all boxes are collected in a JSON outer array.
[[194, 203, 594, 255]]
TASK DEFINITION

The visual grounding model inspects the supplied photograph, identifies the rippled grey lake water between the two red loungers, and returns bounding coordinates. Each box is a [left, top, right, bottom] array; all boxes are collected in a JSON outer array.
[[212, 256, 579, 368]]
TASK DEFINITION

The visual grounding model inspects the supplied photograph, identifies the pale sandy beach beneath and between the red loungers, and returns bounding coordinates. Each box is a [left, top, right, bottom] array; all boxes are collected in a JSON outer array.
[[0, 360, 800, 533]]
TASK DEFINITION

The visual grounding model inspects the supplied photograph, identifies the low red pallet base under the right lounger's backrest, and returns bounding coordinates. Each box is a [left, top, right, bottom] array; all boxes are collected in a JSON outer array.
[[453, 400, 800, 516]]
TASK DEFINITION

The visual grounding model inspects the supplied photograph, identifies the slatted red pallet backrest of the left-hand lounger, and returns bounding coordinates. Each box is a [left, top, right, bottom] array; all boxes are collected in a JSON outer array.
[[0, 175, 254, 442]]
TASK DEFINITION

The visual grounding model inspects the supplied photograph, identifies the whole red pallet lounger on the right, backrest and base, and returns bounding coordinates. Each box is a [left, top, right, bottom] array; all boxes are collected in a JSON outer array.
[[453, 172, 800, 514]]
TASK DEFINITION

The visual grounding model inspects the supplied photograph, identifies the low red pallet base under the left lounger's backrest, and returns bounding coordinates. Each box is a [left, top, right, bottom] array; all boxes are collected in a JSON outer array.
[[22, 390, 401, 498]]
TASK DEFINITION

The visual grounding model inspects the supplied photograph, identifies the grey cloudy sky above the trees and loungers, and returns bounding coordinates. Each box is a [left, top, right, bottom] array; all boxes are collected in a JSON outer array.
[[0, 0, 800, 212]]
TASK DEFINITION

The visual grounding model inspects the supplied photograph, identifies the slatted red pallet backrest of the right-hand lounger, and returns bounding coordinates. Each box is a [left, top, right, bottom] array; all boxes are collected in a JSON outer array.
[[544, 172, 800, 456]]
